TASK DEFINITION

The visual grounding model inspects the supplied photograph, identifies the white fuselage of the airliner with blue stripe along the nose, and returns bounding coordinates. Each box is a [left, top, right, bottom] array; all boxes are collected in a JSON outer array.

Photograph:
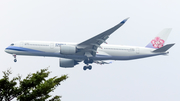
[[5, 41, 167, 61]]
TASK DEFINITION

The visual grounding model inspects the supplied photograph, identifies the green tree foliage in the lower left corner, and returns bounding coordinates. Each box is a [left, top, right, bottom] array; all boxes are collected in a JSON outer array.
[[0, 69, 68, 101]]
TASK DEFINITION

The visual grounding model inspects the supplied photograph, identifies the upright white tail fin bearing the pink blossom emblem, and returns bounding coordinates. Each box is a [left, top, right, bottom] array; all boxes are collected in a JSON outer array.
[[146, 28, 172, 49]]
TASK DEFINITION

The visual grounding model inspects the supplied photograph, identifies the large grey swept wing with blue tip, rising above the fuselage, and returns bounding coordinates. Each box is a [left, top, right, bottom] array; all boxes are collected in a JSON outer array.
[[77, 18, 129, 57]]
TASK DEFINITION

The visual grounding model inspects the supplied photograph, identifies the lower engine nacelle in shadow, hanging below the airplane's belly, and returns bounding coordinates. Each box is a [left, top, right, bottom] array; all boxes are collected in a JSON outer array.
[[59, 58, 77, 68]]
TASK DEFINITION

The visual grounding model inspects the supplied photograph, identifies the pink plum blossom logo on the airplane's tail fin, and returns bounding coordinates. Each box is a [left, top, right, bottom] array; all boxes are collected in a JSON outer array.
[[151, 37, 165, 48]]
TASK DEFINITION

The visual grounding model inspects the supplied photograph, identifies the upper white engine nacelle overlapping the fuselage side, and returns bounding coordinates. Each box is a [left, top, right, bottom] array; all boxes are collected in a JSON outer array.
[[60, 45, 77, 55]]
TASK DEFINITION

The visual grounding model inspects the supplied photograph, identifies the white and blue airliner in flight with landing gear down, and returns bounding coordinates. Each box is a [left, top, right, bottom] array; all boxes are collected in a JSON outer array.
[[5, 18, 175, 70]]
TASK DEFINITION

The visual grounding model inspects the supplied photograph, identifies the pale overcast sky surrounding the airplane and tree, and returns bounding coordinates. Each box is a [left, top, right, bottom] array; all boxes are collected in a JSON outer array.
[[0, 0, 180, 101]]
